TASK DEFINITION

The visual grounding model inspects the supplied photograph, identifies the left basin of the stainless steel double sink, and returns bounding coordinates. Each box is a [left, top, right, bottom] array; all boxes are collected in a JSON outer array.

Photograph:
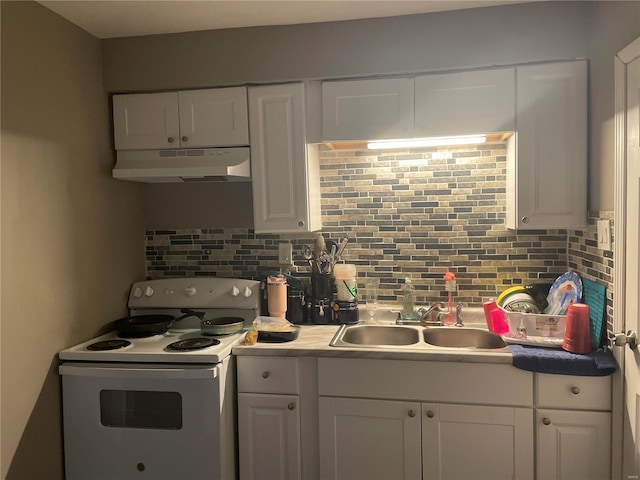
[[330, 325, 421, 347]]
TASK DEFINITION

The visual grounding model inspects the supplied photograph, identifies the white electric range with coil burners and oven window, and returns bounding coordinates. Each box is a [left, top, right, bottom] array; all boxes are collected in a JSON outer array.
[[59, 277, 260, 480]]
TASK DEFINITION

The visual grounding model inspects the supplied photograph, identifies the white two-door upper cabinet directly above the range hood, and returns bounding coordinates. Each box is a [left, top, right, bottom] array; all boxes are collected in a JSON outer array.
[[113, 87, 249, 150]]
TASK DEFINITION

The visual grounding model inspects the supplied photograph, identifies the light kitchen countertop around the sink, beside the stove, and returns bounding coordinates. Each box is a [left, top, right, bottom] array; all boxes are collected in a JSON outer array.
[[233, 324, 513, 365]]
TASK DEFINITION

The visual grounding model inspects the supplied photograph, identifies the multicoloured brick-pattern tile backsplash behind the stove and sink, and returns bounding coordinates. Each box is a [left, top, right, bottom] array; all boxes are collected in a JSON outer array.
[[146, 143, 613, 309]]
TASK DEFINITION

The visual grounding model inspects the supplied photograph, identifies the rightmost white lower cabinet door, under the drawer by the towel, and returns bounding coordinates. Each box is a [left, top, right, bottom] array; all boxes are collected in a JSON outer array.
[[536, 410, 611, 480]]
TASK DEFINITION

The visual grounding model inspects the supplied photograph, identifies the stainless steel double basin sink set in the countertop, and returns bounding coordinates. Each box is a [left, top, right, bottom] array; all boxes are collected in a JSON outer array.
[[329, 325, 507, 350]]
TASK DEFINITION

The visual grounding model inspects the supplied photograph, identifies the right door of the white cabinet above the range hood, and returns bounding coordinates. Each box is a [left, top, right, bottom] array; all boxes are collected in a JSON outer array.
[[178, 87, 249, 148]]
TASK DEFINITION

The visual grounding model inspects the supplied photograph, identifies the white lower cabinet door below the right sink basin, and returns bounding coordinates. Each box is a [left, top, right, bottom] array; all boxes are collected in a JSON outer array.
[[422, 404, 533, 480]]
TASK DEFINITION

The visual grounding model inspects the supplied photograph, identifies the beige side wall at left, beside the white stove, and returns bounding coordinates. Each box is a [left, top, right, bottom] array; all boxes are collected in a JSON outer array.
[[0, 1, 144, 480]]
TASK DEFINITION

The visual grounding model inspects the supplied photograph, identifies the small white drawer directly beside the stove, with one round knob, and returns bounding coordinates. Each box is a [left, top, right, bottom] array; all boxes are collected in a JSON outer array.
[[238, 356, 299, 393]]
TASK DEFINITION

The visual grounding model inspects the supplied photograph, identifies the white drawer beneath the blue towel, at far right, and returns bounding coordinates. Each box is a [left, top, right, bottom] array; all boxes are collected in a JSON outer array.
[[536, 374, 611, 410]]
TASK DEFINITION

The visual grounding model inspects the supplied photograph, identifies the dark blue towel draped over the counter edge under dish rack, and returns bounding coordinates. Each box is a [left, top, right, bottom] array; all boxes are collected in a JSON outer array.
[[509, 345, 618, 377]]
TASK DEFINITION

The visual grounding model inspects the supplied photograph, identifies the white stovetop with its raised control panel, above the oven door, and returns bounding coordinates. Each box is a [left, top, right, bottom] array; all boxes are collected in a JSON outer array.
[[59, 277, 260, 363]]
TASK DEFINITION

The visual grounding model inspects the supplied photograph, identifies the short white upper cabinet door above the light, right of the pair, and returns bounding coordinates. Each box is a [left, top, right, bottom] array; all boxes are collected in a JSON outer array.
[[415, 68, 516, 137]]
